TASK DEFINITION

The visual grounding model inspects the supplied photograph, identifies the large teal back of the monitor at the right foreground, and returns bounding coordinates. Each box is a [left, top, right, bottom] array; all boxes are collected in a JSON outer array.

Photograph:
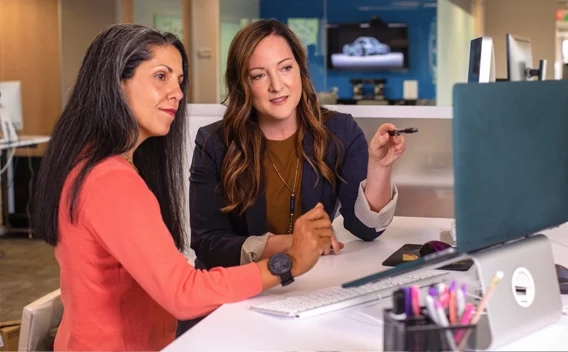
[[452, 81, 568, 252]]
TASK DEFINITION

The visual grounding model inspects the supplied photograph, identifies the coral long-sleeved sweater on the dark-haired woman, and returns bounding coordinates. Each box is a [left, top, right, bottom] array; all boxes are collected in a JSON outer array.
[[55, 156, 262, 351]]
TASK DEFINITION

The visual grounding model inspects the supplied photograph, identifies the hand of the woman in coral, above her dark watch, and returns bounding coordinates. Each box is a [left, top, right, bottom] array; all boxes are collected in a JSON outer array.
[[288, 203, 333, 277]]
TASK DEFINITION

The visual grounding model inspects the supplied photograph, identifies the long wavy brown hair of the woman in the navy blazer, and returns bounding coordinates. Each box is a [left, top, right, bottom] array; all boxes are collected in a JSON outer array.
[[221, 20, 342, 215]]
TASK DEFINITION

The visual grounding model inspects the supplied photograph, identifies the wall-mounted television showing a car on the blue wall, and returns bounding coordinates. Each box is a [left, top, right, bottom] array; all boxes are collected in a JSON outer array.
[[327, 21, 409, 71]]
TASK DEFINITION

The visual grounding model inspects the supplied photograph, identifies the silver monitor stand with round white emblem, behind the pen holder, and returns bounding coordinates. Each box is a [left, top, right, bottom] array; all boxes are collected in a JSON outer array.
[[471, 234, 562, 350]]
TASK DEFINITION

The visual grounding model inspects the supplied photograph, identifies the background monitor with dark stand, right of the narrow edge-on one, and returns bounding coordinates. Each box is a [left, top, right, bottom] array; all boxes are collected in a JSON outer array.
[[506, 34, 546, 81]]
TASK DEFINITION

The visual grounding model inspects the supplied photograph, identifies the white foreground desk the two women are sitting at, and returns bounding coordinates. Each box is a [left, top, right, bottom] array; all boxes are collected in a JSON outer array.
[[164, 217, 568, 352]]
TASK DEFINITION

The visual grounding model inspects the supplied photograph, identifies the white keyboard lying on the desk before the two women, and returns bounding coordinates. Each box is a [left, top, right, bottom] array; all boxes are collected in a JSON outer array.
[[251, 270, 448, 318]]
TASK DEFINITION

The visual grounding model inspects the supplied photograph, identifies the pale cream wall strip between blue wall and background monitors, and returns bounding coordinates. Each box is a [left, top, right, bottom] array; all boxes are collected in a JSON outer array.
[[436, 0, 478, 106]]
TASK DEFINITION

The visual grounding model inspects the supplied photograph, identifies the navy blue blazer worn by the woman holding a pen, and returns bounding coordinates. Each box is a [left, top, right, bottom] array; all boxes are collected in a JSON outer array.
[[189, 113, 383, 268]]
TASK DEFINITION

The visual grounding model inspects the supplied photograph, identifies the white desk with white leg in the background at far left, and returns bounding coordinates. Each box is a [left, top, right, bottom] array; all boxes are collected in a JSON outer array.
[[0, 135, 51, 236]]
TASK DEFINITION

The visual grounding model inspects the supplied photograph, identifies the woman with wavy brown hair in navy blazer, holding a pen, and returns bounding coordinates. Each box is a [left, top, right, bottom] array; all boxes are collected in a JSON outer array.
[[178, 20, 405, 332]]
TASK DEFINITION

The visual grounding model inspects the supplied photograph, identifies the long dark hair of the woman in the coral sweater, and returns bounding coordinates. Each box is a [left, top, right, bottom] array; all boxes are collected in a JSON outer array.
[[32, 24, 188, 250]]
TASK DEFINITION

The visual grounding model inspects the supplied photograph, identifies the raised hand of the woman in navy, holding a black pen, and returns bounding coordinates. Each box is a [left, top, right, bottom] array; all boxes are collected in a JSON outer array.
[[369, 123, 406, 167]]
